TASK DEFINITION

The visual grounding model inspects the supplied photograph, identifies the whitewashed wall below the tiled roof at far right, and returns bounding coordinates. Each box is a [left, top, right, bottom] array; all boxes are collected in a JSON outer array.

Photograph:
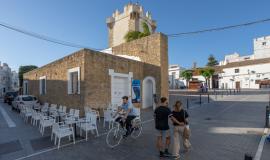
[[219, 62, 270, 89]]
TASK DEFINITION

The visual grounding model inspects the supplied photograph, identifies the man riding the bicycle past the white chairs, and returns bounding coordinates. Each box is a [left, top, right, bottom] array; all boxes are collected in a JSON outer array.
[[115, 96, 136, 137]]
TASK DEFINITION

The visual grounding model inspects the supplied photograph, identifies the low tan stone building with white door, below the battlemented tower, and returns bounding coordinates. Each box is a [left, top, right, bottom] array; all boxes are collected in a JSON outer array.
[[23, 4, 168, 110]]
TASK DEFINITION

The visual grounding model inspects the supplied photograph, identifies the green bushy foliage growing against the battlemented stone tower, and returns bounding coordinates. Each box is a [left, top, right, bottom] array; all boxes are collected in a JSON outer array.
[[124, 22, 150, 42]]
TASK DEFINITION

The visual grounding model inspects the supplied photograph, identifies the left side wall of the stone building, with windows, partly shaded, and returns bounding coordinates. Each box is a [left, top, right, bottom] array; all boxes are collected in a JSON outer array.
[[24, 50, 85, 111]]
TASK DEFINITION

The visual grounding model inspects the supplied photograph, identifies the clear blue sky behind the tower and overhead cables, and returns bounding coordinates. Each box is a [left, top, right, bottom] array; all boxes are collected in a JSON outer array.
[[0, 0, 270, 70]]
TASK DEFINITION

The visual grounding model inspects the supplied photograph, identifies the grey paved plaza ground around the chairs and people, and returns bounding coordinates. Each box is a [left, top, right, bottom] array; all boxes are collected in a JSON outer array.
[[0, 91, 270, 160]]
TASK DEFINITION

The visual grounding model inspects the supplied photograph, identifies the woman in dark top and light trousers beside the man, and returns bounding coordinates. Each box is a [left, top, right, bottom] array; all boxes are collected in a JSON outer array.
[[172, 101, 189, 158]]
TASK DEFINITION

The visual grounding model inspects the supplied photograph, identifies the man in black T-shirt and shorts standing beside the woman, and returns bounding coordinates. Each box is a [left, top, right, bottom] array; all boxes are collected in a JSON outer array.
[[154, 97, 172, 157]]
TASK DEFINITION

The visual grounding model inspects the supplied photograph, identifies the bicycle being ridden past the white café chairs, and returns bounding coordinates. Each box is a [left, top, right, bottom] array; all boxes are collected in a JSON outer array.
[[106, 117, 142, 148]]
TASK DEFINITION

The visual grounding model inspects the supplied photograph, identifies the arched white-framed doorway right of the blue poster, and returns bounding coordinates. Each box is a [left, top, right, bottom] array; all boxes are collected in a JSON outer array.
[[142, 77, 156, 109]]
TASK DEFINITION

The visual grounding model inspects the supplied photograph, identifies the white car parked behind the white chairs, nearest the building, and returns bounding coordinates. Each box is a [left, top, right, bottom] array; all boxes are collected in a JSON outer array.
[[12, 95, 38, 111]]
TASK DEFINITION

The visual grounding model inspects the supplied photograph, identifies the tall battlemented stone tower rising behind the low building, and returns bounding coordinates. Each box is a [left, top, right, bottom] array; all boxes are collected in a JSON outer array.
[[106, 3, 156, 47]]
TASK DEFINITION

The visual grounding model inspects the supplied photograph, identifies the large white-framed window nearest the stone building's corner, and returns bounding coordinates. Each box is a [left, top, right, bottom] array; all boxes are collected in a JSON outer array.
[[68, 67, 80, 94]]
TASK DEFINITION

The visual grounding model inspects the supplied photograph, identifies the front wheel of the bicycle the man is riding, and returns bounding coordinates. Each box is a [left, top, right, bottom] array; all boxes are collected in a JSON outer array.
[[106, 127, 123, 148]]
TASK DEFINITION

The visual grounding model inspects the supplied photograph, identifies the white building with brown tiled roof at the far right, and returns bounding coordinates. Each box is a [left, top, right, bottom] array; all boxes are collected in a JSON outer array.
[[218, 36, 270, 89]]
